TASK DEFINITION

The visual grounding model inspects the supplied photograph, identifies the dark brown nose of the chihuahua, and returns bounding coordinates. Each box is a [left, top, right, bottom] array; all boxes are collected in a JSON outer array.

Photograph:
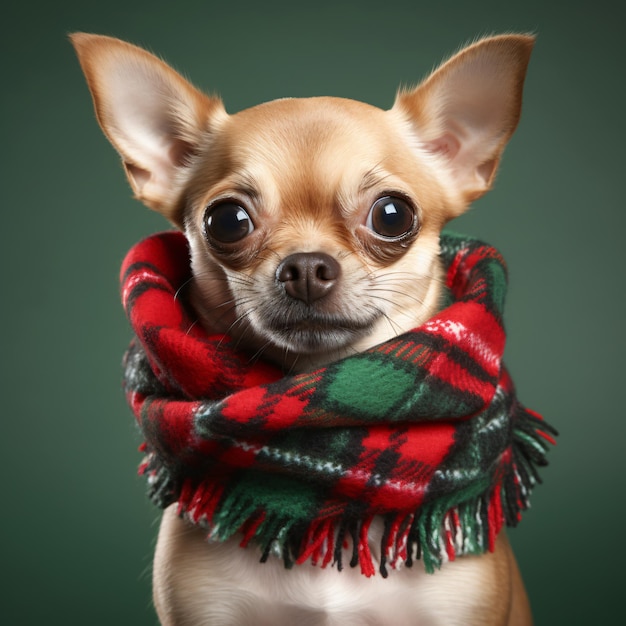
[[276, 252, 341, 304]]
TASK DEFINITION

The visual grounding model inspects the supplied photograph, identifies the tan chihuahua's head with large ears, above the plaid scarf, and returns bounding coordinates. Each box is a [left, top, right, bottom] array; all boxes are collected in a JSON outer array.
[[72, 34, 533, 366]]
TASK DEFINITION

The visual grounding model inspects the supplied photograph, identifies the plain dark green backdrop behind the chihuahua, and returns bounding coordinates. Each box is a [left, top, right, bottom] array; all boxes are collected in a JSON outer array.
[[0, 0, 626, 626]]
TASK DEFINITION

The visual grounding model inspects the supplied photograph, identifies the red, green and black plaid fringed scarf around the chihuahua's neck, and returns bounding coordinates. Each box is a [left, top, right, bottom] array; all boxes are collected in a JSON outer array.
[[122, 232, 556, 576]]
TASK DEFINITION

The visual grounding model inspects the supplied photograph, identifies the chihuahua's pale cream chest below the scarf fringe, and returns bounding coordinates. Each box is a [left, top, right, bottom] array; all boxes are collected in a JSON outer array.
[[154, 509, 490, 626]]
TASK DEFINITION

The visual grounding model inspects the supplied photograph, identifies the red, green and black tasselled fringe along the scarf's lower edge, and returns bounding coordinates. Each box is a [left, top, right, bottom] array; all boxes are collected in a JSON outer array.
[[139, 405, 558, 578]]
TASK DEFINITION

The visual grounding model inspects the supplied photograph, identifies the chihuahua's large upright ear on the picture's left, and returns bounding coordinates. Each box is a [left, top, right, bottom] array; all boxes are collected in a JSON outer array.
[[70, 33, 227, 226]]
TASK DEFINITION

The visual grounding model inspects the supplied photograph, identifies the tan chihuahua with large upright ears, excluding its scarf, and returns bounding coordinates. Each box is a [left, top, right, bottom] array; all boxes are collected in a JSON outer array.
[[72, 34, 533, 626]]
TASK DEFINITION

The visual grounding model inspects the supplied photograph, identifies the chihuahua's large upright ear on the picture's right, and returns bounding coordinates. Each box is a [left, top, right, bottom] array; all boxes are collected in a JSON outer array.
[[393, 35, 534, 203]]
